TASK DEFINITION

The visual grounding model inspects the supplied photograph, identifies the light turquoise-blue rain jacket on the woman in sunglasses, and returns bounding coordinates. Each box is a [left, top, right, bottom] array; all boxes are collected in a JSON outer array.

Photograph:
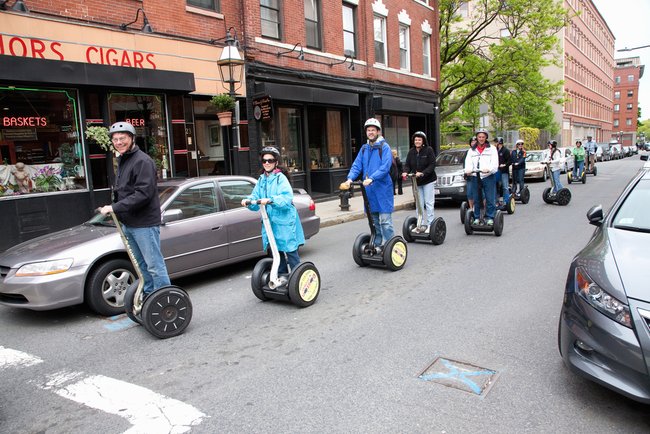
[[248, 169, 305, 252]]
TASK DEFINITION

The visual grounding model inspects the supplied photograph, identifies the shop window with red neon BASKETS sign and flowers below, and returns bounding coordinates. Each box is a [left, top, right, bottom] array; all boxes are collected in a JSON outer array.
[[0, 87, 87, 196]]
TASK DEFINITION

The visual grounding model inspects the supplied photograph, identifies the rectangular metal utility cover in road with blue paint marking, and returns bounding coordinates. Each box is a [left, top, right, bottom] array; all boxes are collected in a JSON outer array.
[[419, 357, 497, 395]]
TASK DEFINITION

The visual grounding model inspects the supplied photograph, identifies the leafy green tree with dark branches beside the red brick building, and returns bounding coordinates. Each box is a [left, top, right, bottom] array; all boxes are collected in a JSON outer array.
[[438, 0, 568, 122]]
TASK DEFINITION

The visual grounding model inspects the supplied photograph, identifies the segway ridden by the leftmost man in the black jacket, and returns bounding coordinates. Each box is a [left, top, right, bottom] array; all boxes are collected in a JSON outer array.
[[111, 211, 192, 339]]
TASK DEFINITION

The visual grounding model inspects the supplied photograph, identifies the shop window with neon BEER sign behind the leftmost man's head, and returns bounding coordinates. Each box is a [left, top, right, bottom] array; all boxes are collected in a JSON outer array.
[[108, 93, 169, 177]]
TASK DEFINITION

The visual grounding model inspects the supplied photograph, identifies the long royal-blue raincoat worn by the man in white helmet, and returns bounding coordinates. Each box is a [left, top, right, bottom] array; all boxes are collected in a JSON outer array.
[[348, 136, 394, 213]]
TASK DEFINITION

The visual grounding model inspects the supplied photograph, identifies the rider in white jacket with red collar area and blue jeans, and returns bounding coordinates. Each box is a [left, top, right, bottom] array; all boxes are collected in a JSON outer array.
[[465, 128, 499, 225]]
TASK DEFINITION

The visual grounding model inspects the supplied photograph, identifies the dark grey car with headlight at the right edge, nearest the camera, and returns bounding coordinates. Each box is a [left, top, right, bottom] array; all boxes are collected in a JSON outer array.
[[558, 168, 650, 404]]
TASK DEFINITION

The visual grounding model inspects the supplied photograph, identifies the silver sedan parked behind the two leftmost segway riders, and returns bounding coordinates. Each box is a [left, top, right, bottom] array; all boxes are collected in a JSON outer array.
[[0, 176, 320, 316]]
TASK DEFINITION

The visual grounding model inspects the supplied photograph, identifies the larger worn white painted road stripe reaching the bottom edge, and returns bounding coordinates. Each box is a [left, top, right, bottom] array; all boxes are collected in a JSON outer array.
[[41, 371, 208, 434]]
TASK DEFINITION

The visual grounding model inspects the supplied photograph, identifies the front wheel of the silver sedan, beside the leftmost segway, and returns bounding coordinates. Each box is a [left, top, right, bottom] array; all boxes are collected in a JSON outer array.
[[84, 259, 136, 316]]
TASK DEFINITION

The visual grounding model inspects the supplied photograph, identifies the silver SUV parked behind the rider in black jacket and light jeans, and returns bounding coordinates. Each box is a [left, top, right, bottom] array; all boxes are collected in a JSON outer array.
[[434, 148, 469, 202]]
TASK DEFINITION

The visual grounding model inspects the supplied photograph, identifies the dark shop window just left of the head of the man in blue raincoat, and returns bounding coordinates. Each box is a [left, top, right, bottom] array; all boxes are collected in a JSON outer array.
[[307, 108, 347, 170]]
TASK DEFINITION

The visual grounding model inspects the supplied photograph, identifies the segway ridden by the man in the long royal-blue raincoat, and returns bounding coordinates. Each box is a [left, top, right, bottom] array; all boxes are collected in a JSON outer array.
[[339, 181, 408, 271]]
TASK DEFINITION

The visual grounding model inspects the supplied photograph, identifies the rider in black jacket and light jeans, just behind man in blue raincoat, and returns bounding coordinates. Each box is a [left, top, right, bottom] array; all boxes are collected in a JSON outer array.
[[401, 131, 436, 233]]
